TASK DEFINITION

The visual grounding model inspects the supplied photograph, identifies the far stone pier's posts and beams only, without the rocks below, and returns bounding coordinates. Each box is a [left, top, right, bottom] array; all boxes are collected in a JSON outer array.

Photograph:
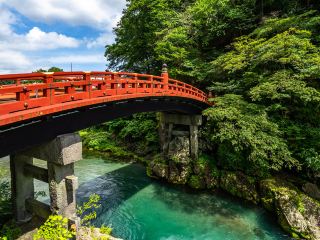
[[159, 113, 202, 159]]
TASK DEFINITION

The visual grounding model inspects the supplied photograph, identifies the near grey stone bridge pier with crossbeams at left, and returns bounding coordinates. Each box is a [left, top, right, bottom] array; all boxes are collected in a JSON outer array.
[[10, 133, 82, 226]]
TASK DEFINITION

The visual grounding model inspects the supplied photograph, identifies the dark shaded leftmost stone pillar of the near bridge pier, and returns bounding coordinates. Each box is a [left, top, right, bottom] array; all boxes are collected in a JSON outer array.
[[10, 154, 34, 223]]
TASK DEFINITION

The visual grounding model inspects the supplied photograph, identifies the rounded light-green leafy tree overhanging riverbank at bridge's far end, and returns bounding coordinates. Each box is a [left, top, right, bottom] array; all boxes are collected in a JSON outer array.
[[204, 94, 299, 175]]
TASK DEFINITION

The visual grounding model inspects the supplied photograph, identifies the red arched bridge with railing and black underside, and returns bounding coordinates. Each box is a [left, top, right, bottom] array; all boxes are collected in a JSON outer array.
[[0, 69, 209, 157]]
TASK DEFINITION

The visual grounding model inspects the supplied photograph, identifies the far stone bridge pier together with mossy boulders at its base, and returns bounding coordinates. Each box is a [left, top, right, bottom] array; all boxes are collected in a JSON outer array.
[[147, 113, 202, 184]]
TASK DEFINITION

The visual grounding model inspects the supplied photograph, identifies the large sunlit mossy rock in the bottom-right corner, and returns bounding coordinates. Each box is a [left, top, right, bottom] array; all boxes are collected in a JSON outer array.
[[260, 178, 320, 240]]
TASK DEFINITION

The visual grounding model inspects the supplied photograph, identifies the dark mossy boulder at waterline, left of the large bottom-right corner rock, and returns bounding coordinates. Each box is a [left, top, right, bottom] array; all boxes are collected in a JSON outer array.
[[220, 171, 259, 204]]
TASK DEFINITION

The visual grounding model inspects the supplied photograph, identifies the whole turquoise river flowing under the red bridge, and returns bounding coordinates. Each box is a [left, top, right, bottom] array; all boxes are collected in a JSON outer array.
[[76, 158, 289, 240]]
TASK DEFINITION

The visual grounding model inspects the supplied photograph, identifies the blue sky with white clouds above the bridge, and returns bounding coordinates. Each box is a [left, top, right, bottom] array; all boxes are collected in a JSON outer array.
[[0, 0, 126, 73]]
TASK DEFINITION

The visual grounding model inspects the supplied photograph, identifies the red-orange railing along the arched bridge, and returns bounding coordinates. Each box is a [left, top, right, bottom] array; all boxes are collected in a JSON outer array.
[[0, 72, 208, 126]]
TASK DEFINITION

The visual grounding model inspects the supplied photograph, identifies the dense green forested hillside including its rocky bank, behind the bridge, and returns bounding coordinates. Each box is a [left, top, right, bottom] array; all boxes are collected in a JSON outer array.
[[87, 0, 320, 239]]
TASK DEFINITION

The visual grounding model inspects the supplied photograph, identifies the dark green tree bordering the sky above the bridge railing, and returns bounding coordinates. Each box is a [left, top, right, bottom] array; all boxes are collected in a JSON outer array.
[[105, 0, 184, 73]]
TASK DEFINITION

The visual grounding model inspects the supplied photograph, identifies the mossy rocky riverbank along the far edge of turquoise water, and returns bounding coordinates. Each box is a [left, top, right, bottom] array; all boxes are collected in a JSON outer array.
[[147, 152, 320, 240]]
